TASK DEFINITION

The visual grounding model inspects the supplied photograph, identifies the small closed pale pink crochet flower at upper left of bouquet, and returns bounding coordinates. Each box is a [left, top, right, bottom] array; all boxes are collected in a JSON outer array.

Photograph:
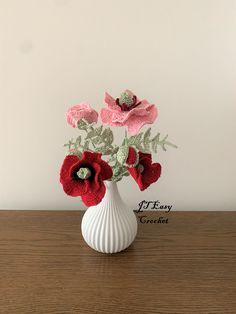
[[66, 102, 98, 128]]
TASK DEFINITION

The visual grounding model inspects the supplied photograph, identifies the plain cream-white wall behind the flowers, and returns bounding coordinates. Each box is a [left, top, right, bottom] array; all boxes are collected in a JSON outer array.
[[0, 0, 236, 210]]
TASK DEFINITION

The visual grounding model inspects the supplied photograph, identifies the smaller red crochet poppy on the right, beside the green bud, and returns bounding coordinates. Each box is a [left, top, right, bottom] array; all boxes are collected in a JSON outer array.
[[126, 147, 161, 191]]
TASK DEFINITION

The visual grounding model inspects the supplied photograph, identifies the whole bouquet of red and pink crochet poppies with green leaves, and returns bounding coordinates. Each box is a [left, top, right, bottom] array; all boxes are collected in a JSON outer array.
[[60, 90, 176, 206]]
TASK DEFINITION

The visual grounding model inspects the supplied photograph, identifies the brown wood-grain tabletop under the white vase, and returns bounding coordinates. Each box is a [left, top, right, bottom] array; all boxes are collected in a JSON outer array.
[[0, 211, 236, 314]]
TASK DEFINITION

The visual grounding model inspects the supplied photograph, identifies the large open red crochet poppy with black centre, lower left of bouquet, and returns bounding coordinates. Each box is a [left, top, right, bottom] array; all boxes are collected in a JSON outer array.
[[60, 152, 112, 206]]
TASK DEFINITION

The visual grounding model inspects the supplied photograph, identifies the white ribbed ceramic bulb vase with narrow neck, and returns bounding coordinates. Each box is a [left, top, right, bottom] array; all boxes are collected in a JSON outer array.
[[81, 181, 138, 253]]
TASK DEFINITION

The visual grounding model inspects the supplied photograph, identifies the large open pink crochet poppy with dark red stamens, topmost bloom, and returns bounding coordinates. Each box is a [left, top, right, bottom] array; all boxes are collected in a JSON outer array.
[[101, 90, 157, 135]]
